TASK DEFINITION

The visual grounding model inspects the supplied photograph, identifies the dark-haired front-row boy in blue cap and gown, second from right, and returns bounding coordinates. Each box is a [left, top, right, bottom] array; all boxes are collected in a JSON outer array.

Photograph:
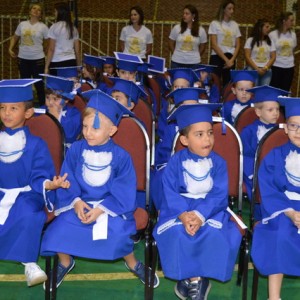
[[154, 104, 241, 299]]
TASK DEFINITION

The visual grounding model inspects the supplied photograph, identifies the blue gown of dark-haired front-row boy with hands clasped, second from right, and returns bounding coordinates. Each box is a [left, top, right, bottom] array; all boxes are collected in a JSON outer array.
[[154, 149, 241, 281]]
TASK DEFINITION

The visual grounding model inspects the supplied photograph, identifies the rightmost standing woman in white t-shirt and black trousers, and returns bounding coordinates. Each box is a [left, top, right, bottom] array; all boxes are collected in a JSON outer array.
[[269, 12, 297, 91]]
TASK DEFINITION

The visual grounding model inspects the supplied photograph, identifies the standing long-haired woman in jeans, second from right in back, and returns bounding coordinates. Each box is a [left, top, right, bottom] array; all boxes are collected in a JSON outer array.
[[244, 19, 276, 86]]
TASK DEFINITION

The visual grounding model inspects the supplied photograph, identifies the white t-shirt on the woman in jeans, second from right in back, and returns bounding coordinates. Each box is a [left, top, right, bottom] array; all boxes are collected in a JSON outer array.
[[244, 37, 276, 68]]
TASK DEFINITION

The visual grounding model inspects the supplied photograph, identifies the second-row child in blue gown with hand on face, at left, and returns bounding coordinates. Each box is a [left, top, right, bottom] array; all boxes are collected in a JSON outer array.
[[42, 75, 82, 147]]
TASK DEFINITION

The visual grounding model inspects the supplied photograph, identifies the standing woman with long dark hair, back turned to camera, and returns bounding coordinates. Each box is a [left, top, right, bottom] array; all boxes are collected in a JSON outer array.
[[45, 2, 80, 75]]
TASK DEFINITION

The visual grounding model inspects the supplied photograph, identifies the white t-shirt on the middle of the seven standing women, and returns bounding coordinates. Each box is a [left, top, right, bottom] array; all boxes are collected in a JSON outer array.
[[169, 24, 207, 64]]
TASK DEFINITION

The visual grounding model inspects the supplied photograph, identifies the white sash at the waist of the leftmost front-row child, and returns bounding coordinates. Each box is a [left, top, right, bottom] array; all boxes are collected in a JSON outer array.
[[0, 185, 31, 225]]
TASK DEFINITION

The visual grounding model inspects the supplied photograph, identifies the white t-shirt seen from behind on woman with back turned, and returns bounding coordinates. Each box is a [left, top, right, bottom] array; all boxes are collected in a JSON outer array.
[[48, 21, 79, 62]]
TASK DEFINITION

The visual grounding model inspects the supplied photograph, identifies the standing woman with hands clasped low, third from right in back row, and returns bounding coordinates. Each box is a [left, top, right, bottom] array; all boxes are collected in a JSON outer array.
[[208, 0, 241, 87]]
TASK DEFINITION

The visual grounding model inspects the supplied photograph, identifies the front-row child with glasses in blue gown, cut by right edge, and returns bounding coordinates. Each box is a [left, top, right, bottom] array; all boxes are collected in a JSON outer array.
[[251, 97, 300, 300]]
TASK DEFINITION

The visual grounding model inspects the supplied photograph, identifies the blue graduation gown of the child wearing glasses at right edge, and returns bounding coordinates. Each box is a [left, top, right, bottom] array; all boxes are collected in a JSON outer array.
[[251, 142, 300, 276]]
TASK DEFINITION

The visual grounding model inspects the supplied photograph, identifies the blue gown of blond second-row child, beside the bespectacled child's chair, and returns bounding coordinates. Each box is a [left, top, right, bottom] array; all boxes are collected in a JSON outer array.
[[241, 119, 276, 200]]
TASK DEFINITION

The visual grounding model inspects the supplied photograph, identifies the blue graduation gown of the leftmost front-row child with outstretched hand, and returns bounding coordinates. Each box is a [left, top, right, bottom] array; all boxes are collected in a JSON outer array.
[[0, 127, 55, 262]]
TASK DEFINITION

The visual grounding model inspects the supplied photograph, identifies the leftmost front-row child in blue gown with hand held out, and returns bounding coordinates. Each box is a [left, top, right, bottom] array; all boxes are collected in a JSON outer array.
[[0, 79, 69, 286]]
